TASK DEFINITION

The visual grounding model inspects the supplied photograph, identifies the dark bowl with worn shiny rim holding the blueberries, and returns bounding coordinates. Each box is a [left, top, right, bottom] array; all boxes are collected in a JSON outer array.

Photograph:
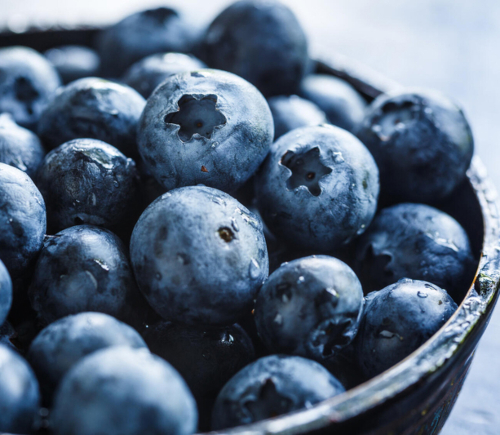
[[0, 28, 500, 435]]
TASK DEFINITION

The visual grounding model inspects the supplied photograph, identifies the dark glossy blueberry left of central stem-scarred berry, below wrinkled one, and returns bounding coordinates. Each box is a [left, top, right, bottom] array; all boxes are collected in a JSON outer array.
[[29, 225, 154, 326]]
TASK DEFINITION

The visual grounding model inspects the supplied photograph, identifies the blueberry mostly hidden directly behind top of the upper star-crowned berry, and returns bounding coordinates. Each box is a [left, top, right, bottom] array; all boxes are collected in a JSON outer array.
[[123, 53, 206, 99]]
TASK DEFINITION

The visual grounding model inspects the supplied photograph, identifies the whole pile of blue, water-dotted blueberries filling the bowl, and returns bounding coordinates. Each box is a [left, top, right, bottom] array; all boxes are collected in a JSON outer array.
[[0, 0, 477, 435]]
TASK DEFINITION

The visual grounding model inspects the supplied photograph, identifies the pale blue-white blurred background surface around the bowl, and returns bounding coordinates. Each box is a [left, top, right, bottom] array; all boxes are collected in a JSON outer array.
[[0, 0, 500, 435]]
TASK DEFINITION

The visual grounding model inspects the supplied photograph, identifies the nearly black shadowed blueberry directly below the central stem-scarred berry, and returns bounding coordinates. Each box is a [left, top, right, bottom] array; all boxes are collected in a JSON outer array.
[[143, 321, 255, 430]]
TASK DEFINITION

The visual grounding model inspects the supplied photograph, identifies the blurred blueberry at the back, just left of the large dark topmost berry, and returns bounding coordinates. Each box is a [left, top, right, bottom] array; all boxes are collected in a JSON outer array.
[[98, 7, 197, 77]]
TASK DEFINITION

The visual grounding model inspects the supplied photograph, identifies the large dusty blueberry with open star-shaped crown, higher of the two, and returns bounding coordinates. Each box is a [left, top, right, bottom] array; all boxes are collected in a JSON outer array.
[[138, 69, 274, 192]]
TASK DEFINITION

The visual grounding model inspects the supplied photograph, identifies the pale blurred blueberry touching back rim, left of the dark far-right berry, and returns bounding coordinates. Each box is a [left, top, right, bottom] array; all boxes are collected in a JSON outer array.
[[300, 74, 366, 131]]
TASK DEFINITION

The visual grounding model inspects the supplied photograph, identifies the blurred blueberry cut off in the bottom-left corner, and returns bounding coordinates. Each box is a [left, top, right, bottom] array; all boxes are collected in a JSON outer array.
[[0, 343, 40, 433]]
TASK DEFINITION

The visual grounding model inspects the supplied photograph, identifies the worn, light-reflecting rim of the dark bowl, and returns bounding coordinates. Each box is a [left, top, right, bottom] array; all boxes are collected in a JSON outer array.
[[209, 55, 500, 435]]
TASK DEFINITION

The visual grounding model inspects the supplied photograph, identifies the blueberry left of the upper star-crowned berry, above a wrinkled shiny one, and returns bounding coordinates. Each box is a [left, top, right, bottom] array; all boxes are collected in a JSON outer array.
[[38, 77, 146, 157]]
